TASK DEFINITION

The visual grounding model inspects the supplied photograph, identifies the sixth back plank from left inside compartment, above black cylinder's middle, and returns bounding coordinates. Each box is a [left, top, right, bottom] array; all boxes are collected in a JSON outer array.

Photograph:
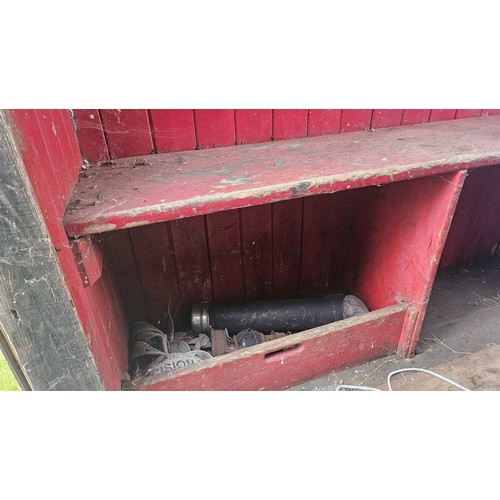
[[272, 199, 304, 298]]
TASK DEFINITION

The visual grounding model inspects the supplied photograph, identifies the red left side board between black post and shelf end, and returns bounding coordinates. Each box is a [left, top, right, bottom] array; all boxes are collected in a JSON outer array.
[[11, 110, 130, 390]]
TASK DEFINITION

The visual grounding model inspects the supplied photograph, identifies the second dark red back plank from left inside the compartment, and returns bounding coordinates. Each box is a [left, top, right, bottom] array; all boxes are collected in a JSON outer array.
[[130, 223, 180, 331]]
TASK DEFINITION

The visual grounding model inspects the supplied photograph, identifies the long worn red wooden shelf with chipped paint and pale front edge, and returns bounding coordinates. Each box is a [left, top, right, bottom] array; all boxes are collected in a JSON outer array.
[[64, 115, 500, 237]]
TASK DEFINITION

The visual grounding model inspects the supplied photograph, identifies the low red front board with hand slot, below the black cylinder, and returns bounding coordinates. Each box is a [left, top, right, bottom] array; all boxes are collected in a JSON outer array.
[[125, 305, 407, 391]]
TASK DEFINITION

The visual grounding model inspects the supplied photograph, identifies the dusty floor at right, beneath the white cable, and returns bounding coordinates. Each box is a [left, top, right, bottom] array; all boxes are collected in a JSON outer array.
[[290, 255, 500, 390]]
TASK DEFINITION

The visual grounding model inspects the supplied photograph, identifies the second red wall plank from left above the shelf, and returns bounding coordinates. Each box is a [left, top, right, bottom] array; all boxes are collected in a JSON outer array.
[[101, 109, 153, 158]]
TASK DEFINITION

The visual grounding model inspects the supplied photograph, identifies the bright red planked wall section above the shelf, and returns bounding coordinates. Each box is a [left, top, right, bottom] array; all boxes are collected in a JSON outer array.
[[72, 109, 500, 163]]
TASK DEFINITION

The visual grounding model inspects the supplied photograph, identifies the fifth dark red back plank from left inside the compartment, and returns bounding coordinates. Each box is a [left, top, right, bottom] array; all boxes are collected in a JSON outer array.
[[240, 204, 273, 300]]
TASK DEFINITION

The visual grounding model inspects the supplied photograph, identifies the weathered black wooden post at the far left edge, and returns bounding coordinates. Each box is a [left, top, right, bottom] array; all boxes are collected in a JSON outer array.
[[0, 111, 104, 390]]
